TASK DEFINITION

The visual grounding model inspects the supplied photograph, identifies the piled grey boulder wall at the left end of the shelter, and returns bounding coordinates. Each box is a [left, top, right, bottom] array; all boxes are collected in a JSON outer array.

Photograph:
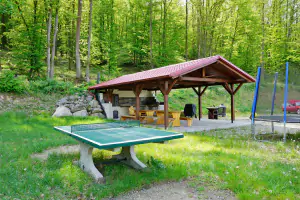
[[52, 94, 104, 118]]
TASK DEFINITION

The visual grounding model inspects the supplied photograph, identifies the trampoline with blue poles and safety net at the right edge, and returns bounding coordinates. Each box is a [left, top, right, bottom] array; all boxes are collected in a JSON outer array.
[[251, 62, 300, 142]]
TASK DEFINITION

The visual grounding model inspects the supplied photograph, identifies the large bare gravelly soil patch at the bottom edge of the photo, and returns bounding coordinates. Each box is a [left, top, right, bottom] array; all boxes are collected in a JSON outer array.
[[106, 181, 236, 200]]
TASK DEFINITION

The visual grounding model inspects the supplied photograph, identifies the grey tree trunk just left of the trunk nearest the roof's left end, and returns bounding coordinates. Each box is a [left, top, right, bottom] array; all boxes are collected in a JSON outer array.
[[75, 0, 82, 81]]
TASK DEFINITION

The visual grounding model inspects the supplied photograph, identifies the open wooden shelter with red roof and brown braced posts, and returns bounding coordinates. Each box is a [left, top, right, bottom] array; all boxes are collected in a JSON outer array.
[[88, 55, 255, 128]]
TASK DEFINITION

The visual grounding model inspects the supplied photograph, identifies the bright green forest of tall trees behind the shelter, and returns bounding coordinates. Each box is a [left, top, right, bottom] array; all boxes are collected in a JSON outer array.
[[0, 0, 300, 82]]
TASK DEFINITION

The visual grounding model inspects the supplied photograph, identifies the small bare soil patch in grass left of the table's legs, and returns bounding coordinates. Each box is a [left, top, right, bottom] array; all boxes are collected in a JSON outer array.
[[31, 145, 79, 161]]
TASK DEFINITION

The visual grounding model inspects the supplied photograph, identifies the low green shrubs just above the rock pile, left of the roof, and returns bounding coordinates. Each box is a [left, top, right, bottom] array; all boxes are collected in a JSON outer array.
[[29, 80, 88, 94]]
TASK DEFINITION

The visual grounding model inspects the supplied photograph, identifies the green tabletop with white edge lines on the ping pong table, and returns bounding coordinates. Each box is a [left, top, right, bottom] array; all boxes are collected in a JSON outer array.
[[55, 124, 183, 149]]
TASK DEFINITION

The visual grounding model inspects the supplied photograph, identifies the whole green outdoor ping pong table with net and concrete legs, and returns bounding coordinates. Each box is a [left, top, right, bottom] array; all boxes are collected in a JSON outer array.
[[54, 121, 183, 182]]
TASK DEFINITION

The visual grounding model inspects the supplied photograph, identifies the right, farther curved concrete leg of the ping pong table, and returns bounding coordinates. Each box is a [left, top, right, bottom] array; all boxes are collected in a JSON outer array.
[[114, 146, 147, 170]]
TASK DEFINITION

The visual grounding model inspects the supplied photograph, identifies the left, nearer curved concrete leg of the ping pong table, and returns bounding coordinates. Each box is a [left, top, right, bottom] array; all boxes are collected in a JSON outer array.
[[78, 142, 105, 183]]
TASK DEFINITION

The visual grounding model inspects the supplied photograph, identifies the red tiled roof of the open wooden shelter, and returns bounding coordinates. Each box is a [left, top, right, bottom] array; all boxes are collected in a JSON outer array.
[[88, 55, 255, 90]]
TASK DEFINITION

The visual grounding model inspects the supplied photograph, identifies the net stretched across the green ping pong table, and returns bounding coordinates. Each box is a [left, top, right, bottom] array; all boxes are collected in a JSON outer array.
[[71, 120, 140, 133]]
